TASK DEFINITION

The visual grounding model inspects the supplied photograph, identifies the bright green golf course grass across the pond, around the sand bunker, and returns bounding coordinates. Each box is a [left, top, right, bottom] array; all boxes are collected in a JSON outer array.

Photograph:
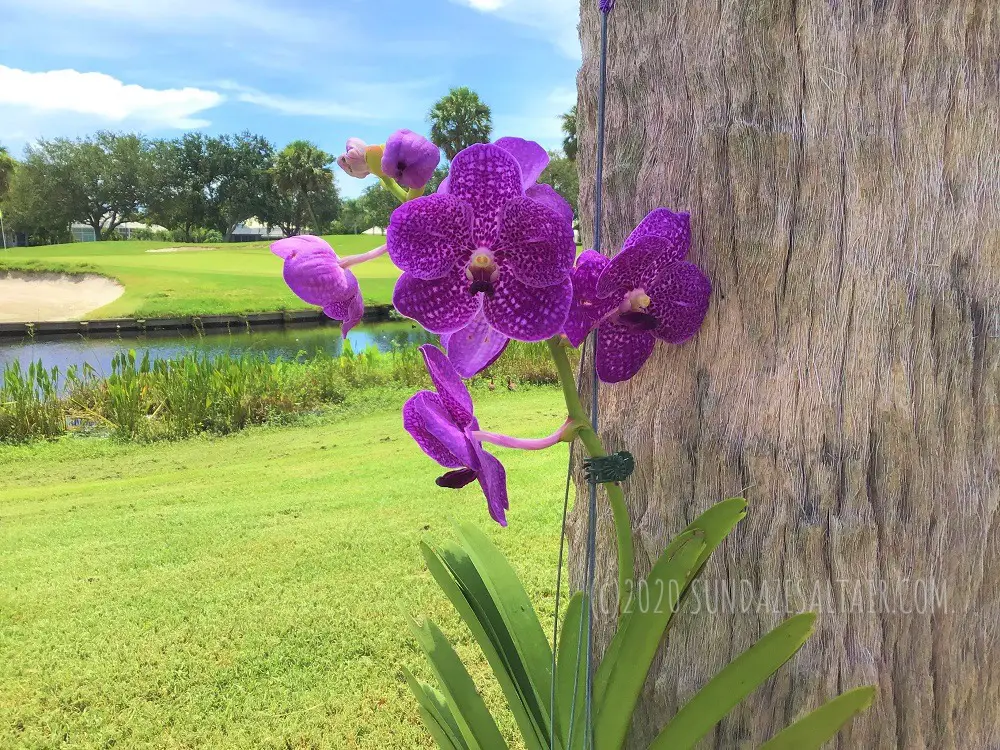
[[0, 235, 399, 318]]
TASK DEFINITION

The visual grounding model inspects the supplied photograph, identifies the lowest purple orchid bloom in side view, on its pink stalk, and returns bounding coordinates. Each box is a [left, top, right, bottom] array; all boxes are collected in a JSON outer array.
[[403, 344, 573, 526]]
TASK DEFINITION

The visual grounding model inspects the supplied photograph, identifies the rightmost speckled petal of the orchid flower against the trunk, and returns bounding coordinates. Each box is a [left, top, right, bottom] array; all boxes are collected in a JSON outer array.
[[646, 262, 712, 344]]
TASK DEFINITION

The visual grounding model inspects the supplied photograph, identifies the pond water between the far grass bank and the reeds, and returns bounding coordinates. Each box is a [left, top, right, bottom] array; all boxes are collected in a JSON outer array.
[[0, 322, 432, 382]]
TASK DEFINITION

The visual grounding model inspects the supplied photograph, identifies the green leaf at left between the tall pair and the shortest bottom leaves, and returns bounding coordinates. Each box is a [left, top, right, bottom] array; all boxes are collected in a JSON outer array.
[[409, 619, 507, 750]]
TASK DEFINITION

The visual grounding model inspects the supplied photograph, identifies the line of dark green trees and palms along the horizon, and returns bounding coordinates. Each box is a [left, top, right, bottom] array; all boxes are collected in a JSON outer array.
[[0, 87, 579, 244]]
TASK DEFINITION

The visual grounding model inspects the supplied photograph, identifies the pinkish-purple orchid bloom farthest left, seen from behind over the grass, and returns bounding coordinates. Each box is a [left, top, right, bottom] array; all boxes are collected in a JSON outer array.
[[271, 234, 365, 336]]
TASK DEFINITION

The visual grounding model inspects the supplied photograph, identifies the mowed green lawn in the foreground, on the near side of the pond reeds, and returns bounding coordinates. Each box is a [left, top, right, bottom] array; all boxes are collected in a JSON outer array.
[[0, 388, 566, 750]]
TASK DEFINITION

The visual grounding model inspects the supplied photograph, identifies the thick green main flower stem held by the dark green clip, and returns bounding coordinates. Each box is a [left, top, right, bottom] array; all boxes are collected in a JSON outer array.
[[548, 336, 635, 615]]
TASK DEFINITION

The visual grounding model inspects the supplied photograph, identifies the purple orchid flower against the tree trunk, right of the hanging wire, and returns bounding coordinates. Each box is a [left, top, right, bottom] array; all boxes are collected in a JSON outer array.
[[565, 208, 712, 383]]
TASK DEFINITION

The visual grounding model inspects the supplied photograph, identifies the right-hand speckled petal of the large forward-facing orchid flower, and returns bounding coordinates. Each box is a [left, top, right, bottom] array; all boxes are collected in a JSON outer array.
[[496, 198, 576, 287]]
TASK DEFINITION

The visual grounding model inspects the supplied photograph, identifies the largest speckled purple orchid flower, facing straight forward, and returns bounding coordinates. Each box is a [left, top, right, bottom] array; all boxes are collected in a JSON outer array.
[[387, 144, 576, 341]]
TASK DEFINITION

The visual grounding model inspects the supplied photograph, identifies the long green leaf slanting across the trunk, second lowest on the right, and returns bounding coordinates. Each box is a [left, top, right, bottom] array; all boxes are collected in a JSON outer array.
[[649, 612, 816, 750]]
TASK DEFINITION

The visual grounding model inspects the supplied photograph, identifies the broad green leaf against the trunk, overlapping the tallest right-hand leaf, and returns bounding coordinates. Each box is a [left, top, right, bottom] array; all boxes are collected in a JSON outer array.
[[594, 529, 705, 750]]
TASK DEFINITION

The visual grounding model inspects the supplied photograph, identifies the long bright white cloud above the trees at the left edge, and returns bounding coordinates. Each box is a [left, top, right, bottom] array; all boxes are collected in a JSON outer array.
[[0, 65, 223, 129]]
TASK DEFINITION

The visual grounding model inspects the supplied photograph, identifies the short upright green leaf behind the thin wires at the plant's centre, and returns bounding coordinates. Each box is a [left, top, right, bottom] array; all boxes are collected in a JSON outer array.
[[556, 591, 589, 750]]
